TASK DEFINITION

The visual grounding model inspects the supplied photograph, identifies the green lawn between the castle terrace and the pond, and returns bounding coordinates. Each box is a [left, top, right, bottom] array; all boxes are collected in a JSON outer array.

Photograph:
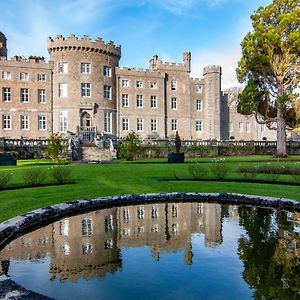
[[0, 156, 300, 222]]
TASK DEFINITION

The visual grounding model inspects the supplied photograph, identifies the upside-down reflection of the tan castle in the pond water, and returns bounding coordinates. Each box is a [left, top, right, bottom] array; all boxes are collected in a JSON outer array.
[[0, 203, 238, 281]]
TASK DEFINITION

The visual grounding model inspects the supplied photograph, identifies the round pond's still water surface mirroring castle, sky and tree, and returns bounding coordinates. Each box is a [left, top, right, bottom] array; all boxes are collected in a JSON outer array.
[[0, 202, 300, 300]]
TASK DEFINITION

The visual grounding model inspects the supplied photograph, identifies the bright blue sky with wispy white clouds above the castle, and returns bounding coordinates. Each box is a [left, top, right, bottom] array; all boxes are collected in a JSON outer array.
[[0, 0, 272, 89]]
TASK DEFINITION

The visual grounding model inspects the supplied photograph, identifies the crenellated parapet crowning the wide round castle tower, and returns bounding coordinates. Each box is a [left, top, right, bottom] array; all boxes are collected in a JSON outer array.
[[48, 34, 121, 58]]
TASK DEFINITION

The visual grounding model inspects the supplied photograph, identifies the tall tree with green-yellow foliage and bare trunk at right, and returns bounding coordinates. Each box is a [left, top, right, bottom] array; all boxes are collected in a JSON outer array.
[[236, 0, 300, 156]]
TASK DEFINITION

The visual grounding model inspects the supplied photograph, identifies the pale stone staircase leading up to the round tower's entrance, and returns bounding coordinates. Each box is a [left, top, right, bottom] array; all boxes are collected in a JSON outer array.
[[79, 145, 113, 163]]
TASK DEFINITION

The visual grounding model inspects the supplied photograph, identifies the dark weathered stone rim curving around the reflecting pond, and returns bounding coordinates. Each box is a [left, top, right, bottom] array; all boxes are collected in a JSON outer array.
[[0, 192, 300, 300]]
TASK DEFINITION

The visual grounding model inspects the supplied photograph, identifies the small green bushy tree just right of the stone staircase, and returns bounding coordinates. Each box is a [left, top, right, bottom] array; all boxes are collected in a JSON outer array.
[[119, 131, 141, 161]]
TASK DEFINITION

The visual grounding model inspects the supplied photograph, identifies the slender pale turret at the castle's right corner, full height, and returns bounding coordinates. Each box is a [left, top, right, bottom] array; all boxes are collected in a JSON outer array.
[[203, 66, 222, 140]]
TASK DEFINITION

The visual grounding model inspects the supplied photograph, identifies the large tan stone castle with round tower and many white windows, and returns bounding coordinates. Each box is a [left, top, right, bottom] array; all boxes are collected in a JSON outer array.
[[0, 32, 275, 141]]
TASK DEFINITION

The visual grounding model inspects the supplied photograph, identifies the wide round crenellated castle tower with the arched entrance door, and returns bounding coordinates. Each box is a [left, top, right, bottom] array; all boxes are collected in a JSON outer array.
[[48, 35, 121, 135]]
